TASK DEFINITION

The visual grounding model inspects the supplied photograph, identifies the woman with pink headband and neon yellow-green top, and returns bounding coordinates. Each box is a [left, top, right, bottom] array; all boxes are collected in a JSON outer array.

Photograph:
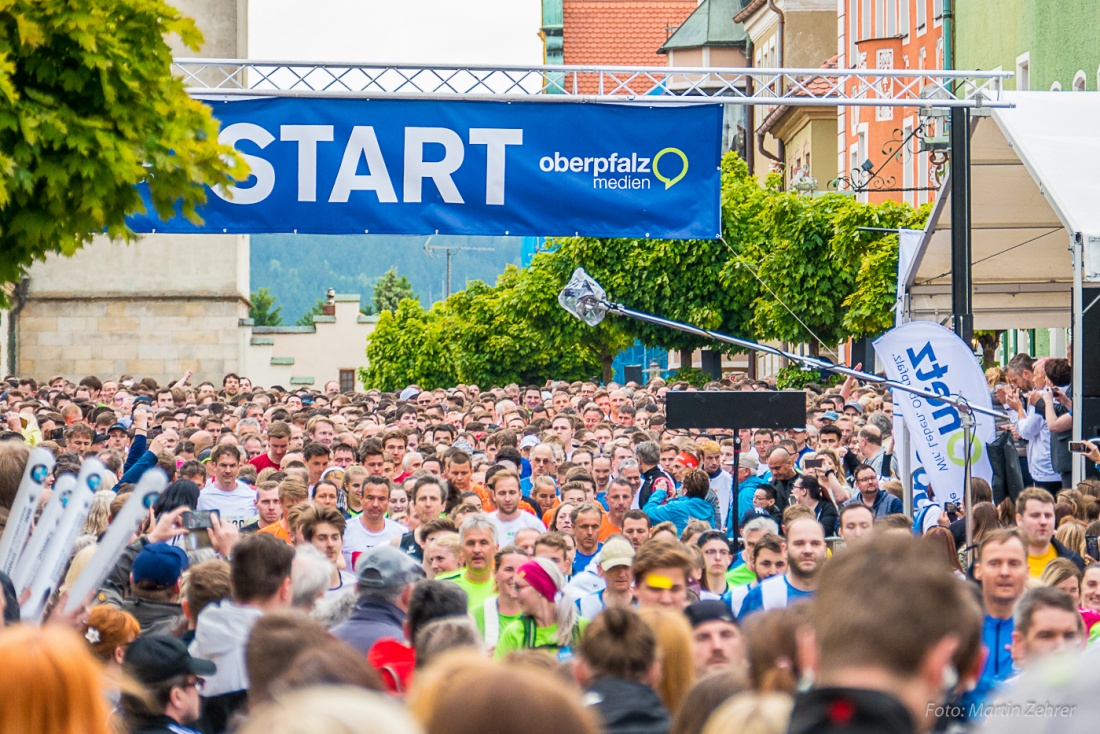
[[493, 558, 587, 661]]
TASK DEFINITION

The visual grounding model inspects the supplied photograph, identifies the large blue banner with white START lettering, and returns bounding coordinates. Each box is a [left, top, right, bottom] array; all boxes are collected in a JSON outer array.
[[130, 98, 722, 239]]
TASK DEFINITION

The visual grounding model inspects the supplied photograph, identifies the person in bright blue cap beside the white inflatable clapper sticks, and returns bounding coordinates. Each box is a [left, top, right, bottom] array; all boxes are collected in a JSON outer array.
[[122, 543, 187, 636]]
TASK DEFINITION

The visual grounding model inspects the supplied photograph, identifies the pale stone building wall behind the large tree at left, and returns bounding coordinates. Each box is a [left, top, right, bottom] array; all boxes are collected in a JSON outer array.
[[13, 0, 251, 384]]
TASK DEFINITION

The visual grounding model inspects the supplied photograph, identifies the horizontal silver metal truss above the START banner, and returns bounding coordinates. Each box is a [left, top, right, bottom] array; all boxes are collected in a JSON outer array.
[[174, 58, 1012, 109]]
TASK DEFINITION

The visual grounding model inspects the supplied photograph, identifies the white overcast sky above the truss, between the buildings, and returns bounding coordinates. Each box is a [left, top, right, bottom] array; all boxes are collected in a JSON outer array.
[[249, 0, 542, 66]]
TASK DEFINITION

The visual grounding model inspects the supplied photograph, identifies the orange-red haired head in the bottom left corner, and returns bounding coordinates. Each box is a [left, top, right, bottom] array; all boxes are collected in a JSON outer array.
[[0, 625, 112, 734]]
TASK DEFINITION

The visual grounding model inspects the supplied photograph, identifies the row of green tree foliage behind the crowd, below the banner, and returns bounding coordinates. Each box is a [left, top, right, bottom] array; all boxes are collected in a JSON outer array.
[[361, 154, 927, 390]]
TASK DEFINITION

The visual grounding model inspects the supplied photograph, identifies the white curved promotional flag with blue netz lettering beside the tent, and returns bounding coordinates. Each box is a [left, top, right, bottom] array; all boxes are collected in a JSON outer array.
[[875, 321, 997, 505]]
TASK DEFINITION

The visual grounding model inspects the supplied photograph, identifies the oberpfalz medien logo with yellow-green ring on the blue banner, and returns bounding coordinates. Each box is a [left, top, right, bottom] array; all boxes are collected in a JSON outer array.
[[539, 147, 688, 190]]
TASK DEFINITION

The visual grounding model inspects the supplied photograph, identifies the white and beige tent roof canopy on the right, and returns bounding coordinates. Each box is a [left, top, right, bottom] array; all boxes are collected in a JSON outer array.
[[910, 92, 1100, 329]]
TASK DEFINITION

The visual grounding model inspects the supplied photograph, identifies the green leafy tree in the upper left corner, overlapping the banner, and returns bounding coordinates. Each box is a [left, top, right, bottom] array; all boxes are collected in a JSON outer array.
[[0, 0, 244, 292]]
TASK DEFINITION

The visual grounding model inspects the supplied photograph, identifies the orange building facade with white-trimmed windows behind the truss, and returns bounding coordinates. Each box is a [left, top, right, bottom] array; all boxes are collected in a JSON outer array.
[[836, 0, 945, 206]]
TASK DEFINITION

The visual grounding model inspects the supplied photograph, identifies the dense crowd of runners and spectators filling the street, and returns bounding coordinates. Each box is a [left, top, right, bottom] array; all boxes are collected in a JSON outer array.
[[0, 365, 1100, 734]]
